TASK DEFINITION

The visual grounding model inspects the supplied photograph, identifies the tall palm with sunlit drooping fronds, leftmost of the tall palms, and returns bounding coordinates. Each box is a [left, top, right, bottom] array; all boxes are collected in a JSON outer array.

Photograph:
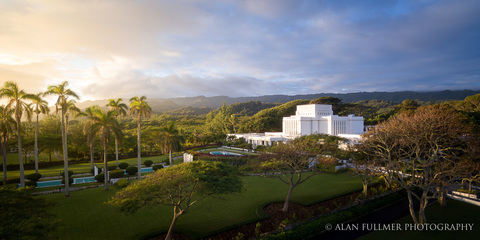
[[0, 82, 35, 187]]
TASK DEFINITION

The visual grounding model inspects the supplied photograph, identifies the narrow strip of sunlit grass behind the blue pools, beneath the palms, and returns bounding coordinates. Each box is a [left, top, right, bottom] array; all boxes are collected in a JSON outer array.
[[7, 155, 178, 178]]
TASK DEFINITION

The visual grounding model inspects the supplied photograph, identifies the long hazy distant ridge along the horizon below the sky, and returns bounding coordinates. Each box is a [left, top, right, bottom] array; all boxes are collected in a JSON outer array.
[[73, 90, 480, 113]]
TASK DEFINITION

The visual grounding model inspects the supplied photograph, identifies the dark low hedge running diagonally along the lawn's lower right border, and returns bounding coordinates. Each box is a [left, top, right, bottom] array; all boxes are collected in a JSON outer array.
[[262, 190, 405, 240]]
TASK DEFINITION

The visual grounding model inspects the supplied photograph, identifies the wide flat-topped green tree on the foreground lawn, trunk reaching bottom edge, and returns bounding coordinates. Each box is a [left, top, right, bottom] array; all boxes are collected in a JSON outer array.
[[108, 161, 243, 239]]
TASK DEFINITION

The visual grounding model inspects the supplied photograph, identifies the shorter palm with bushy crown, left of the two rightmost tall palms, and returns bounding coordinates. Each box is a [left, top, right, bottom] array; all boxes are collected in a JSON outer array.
[[90, 107, 122, 190]]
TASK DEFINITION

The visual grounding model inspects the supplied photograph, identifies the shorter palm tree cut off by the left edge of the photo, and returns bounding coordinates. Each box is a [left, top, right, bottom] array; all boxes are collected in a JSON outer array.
[[0, 105, 16, 181]]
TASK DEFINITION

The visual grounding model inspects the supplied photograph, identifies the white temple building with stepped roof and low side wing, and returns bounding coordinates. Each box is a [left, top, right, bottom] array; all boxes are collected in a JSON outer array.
[[229, 104, 364, 146]]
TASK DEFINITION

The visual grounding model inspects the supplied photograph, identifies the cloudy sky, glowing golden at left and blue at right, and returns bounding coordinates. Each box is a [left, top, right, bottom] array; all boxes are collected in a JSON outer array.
[[0, 0, 480, 101]]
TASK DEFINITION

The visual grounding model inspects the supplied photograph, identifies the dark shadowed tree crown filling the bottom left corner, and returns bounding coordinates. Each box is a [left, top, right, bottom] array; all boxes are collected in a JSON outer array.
[[0, 189, 58, 239]]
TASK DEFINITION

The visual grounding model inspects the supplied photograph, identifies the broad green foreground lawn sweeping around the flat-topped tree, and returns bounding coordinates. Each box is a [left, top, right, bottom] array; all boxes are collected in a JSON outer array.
[[45, 174, 361, 239]]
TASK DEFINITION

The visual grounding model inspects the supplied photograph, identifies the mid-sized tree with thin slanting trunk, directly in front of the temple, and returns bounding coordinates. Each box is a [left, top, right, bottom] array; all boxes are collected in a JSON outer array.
[[259, 137, 336, 212]]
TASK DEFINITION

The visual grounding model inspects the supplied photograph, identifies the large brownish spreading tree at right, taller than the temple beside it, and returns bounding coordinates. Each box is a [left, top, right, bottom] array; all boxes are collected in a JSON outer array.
[[364, 105, 472, 224]]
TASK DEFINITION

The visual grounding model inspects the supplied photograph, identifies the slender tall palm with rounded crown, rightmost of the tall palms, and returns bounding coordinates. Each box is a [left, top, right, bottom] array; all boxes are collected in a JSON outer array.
[[130, 96, 152, 179]]
